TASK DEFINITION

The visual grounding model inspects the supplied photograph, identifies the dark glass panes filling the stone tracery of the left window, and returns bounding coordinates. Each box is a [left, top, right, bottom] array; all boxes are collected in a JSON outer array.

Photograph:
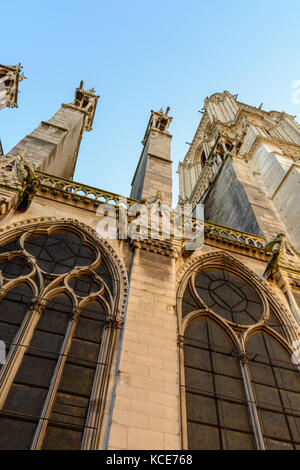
[[0, 229, 115, 450]]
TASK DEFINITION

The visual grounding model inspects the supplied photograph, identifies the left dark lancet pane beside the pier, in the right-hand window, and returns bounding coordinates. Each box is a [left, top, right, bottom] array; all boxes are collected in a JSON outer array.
[[184, 317, 253, 450]]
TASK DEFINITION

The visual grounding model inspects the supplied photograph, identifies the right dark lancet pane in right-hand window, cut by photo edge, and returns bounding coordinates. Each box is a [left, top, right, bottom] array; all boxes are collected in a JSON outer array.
[[247, 332, 300, 450]]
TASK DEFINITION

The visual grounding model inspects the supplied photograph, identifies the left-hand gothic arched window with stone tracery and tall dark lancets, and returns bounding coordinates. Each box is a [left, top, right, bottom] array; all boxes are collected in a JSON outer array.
[[0, 225, 123, 449]]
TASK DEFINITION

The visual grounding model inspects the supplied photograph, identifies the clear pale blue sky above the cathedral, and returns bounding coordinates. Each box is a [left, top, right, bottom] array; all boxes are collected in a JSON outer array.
[[0, 0, 300, 206]]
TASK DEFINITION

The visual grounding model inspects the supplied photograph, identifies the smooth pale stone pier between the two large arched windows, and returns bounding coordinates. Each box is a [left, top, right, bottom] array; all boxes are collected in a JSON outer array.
[[108, 249, 181, 449]]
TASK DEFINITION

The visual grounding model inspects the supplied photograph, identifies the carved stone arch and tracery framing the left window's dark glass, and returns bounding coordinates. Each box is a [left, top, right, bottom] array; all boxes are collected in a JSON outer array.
[[0, 217, 128, 449]]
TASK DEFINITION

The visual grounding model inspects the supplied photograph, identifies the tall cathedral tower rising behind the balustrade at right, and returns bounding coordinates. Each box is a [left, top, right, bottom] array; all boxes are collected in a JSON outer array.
[[178, 91, 300, 250]]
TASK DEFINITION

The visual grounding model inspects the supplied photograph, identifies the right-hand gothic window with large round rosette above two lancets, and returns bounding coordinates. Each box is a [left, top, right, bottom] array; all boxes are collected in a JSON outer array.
[[178, 258, 300, 449]]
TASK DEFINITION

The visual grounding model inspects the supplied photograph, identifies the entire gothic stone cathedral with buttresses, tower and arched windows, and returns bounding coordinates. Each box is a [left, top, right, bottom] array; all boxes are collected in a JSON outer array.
[[0, 65, 300, 450]]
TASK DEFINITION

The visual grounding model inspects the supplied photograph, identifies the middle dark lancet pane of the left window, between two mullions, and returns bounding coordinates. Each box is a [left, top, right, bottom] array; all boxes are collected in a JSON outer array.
[[0, 294, 72, 449]]
